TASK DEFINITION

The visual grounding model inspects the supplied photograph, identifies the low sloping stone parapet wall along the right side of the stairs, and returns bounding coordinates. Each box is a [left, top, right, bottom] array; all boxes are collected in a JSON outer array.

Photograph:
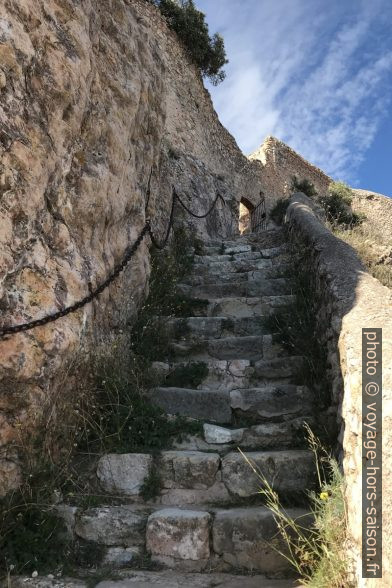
[[286, 194, 392, 588]]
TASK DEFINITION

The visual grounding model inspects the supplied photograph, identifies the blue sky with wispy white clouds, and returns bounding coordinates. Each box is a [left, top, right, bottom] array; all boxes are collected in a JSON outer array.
[[196, 0, 392, 196]]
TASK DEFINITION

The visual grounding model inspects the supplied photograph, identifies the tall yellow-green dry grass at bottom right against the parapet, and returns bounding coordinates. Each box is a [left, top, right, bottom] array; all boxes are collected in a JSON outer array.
[[241, 427, 352, 588]]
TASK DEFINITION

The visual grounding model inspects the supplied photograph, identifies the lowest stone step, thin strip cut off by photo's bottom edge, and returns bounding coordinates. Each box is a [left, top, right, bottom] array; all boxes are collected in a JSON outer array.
[[95, 570, 297, 588]]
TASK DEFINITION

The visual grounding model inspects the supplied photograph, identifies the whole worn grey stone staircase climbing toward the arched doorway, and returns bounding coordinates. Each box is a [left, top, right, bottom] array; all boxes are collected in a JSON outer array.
[[59, 229, 315, 588]]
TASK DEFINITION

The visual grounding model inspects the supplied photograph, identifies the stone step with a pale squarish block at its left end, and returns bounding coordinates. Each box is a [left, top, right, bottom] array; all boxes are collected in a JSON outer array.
[[93, 450, 315, 504]]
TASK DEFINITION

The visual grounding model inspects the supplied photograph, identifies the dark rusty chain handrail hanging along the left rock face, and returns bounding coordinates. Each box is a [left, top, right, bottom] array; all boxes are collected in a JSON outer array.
[[0, 189, 225, 339]]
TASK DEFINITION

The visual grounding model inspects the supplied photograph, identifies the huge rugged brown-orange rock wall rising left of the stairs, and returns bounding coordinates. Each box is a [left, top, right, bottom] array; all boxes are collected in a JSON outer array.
[[0, 0, 259, 495]]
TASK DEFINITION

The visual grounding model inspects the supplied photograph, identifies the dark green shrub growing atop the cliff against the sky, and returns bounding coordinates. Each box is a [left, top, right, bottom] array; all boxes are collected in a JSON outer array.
[[155, 0, 228, 85]]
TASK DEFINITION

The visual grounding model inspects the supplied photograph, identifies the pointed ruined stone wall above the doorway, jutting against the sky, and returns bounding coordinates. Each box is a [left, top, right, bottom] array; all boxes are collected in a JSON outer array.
[[249, 137, 332, 209]]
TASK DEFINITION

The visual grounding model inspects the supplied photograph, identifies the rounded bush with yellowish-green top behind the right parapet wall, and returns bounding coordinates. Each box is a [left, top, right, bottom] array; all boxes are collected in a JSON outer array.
[[320, 182, 364, 228]]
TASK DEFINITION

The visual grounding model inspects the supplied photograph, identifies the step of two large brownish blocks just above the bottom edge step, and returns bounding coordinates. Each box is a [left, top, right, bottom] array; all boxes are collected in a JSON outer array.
[[146, 507, 307, 574]]
